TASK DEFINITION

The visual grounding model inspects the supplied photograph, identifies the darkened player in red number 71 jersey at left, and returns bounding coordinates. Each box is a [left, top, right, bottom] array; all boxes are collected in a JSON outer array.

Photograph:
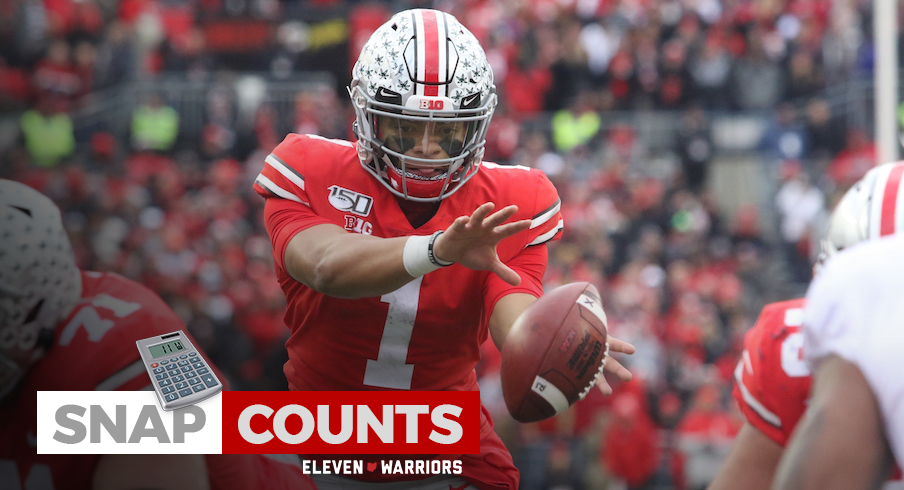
[[0, 180, 314, 490]]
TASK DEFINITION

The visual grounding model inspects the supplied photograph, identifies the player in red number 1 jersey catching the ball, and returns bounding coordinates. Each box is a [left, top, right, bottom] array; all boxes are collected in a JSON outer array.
[[254, 9, 634, 490]]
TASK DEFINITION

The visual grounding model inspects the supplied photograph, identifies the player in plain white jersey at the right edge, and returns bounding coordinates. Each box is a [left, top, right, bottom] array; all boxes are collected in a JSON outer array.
[[773, 233, 904, 490]]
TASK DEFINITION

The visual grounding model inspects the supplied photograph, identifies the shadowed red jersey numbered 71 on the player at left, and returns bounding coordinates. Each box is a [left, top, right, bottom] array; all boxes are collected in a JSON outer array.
[[0, 272, 312, 490]]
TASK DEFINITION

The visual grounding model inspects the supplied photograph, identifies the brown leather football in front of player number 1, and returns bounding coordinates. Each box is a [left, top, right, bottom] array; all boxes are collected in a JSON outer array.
[[502, 282, 609, 422]]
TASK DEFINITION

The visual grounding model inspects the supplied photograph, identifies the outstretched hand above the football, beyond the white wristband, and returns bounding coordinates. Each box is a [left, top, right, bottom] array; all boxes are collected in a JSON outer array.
[[433, 202, 530, 286]]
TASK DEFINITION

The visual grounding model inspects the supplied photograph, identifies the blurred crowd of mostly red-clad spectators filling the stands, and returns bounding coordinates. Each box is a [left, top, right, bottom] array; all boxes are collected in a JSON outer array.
[[0, 0, 888, 490]]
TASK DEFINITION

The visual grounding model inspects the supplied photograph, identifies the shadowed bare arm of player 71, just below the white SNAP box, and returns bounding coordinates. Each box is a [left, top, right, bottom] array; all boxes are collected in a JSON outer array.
[[92, 454, 210, 490]]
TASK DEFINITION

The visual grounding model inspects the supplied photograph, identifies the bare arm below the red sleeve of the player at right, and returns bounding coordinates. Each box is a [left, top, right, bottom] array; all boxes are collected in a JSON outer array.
[[707, 423, 784, 490]]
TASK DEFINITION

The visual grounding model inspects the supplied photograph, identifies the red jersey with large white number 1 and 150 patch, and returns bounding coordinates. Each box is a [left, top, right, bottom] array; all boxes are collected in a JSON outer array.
[[254, 134, 563, 390]]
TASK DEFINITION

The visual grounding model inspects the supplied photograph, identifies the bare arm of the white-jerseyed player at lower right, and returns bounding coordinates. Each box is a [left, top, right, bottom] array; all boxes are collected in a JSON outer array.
[[773, 355, 892, 490]]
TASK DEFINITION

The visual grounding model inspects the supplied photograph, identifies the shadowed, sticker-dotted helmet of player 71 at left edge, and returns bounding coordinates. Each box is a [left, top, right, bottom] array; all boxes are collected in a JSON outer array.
[[0, 179, 82, 398]]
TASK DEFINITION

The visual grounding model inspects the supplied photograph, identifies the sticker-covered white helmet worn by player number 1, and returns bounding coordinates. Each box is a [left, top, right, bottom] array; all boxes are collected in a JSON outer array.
[[349, 9, 496, 202]]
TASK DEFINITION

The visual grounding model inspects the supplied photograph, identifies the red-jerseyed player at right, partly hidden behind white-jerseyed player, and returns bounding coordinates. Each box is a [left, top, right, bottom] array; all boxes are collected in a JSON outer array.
[[709, 162, 904, 490]]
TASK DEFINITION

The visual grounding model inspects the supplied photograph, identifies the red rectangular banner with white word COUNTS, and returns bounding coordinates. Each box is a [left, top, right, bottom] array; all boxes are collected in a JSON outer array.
[[223, 391, 480, 454]]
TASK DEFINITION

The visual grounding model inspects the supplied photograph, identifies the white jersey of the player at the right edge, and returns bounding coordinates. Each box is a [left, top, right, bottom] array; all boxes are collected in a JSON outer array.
[[804, 236, 904, 470]]
